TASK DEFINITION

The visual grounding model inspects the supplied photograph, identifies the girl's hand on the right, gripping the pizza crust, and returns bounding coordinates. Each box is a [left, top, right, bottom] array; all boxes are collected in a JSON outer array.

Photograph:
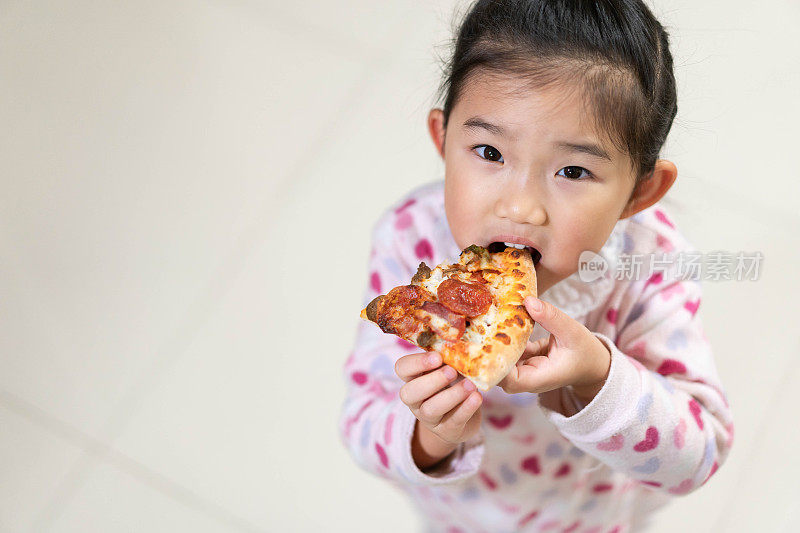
[[497, 296, 611, 400]]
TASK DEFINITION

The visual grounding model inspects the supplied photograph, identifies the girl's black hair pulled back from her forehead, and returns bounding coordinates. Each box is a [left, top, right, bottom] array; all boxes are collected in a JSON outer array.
[[437, 0, 678, 185]]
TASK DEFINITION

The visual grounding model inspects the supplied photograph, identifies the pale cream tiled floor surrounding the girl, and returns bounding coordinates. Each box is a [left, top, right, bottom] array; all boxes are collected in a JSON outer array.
[[0, 0, 800, 533]]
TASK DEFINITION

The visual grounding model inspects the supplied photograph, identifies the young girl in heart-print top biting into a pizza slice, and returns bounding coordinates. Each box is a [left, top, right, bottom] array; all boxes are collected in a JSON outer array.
[[340, 0, 733, 533]]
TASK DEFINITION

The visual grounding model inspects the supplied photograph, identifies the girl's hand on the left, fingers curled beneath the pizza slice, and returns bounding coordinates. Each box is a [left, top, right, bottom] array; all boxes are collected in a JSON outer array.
[[394, 352, 483, 445]]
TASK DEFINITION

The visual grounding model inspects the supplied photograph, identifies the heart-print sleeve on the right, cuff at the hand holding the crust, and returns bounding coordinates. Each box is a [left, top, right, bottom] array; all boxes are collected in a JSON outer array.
[[543, 261, 733, 495]]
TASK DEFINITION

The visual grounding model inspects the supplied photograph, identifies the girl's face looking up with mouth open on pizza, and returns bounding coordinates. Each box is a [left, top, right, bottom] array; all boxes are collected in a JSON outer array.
[[429, 71, 634, 294]]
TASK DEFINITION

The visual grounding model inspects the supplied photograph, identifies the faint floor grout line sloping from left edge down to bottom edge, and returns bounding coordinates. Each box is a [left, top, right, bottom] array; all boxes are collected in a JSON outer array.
[[0, 389, 264, 532]]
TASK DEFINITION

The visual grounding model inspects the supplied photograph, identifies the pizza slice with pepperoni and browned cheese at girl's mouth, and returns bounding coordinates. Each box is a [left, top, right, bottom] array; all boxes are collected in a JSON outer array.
[[361, 244, 538, 392]]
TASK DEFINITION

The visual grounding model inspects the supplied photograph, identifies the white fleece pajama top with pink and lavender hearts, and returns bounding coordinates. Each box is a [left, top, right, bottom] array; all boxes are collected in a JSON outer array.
[[339, 181, 733, 533]]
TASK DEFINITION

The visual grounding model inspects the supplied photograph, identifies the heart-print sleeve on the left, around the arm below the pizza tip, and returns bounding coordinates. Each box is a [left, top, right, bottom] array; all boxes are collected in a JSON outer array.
[[339, 208, 484, 485]]
